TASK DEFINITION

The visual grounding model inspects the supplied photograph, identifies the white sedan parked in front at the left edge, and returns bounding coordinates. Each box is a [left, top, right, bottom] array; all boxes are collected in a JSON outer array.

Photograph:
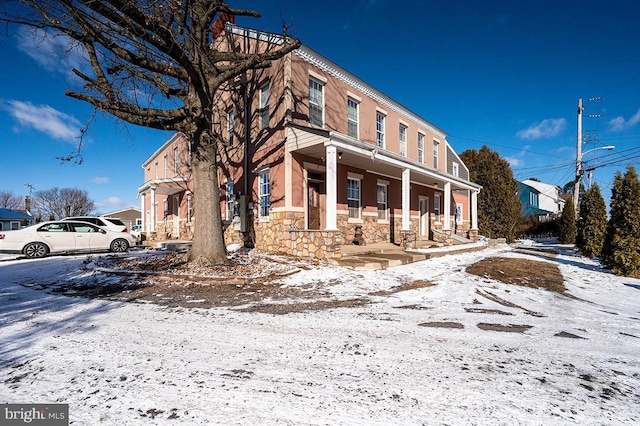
[[0, 220, 135, 258]]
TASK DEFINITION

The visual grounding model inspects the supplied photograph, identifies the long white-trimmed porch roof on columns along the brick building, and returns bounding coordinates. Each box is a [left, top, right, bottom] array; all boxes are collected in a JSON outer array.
[[287, 125, 482, 191]]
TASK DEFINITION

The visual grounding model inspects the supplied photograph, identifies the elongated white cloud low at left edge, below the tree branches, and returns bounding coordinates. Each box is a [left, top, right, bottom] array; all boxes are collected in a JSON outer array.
[[0, 99, 82, 143]]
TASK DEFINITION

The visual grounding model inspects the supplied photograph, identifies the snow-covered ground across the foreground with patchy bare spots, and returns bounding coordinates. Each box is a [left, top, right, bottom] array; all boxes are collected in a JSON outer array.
[[0, 243, 640, 425]]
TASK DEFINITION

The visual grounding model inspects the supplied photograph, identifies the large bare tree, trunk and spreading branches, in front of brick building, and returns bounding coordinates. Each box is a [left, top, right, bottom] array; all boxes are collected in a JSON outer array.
[[0, 0, 300, 263]]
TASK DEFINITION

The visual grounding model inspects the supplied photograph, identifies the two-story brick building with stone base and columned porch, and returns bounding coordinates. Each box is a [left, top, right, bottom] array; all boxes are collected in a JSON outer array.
[[138, 24, 481, 258]]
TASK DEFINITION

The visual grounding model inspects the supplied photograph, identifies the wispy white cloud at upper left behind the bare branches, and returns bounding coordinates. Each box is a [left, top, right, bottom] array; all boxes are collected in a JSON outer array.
[[17, 27, 88, 78]]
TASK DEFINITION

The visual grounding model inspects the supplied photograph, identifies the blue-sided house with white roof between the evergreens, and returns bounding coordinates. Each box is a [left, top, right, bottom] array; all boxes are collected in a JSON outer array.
[[518, 179, 565, 221]]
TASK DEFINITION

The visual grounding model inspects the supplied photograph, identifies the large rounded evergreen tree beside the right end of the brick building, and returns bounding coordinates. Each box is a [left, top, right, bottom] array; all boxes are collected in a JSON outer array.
[[460, 146, 522, 242]]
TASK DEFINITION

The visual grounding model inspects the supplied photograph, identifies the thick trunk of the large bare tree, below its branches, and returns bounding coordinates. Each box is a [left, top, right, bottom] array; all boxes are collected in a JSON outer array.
[[188, 134, 227, 264]]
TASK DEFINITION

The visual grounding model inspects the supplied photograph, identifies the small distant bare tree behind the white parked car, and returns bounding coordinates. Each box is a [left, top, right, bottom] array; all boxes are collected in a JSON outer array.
[[32, 187, 95, 219]]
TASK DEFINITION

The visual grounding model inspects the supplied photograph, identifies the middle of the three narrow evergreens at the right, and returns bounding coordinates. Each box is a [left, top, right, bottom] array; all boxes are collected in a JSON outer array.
[[576, 185, 607, 257]]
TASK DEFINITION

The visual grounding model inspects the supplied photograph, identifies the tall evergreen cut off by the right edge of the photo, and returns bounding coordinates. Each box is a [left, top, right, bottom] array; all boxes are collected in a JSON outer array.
[[602, 166, 640, 277]]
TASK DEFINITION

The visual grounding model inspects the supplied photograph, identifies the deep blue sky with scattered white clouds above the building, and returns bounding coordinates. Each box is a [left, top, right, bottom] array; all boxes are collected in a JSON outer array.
[[0, 0, 640, 212]]
